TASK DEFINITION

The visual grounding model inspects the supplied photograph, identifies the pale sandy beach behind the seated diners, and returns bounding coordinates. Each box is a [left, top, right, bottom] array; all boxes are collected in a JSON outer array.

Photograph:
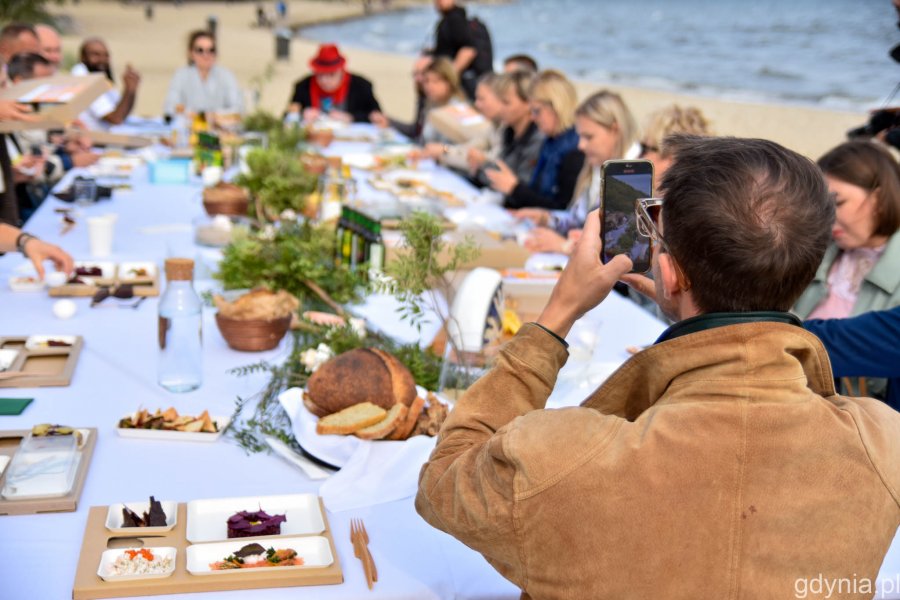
[[51, 0, 867, 158]]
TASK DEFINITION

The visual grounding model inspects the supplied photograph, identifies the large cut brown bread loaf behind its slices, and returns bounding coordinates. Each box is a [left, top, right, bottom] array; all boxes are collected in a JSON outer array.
[[304, 348, 416, 416]]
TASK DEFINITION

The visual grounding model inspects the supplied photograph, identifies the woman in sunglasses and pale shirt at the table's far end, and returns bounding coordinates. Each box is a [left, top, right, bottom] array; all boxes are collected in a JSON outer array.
[[163, 31, 244, 116]]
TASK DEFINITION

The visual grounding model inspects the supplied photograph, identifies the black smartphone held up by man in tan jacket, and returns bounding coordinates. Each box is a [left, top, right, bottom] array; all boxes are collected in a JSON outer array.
[[600, 159, 653, 273]]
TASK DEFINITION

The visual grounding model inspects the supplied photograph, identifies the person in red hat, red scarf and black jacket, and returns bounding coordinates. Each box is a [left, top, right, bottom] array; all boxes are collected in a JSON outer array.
[[288, 44, 381, 123]]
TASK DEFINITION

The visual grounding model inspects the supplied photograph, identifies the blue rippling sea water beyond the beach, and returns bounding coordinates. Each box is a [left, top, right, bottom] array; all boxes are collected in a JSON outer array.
[[300, 0, 900, 110]]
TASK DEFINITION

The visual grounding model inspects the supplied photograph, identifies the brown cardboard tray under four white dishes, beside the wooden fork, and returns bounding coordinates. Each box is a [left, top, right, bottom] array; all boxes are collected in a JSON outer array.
[[72, 498, 344, 600]]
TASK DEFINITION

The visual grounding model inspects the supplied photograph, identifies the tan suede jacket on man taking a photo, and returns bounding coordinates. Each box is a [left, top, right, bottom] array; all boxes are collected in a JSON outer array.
[[416, 322, 900, 600]]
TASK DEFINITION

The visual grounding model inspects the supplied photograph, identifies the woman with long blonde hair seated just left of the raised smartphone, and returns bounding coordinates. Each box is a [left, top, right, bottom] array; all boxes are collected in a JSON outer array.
[[514, 90, 638, 254]]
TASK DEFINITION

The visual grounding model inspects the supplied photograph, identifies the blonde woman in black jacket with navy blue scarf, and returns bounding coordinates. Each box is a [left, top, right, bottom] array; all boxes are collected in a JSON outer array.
[[484, 70, 584, 210]]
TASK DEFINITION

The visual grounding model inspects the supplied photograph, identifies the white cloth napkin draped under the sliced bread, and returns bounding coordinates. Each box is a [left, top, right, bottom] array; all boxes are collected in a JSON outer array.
[[278, 388, 435, 512]]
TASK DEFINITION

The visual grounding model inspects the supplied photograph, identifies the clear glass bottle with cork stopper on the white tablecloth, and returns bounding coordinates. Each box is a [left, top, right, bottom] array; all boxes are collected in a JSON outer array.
[[157, 258, 203, 392]]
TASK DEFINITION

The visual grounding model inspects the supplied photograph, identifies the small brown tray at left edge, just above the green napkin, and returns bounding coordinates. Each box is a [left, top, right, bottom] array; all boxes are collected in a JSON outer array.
[[0, 335, 84, 388]]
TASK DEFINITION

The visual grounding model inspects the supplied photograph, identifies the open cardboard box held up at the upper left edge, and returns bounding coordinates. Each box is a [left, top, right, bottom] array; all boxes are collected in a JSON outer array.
[[0, 73, 111, 133]]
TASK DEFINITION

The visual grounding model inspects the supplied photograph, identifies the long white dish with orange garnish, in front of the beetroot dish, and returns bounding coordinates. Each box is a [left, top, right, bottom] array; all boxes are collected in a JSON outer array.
[[187, 536, 334, 575]]
